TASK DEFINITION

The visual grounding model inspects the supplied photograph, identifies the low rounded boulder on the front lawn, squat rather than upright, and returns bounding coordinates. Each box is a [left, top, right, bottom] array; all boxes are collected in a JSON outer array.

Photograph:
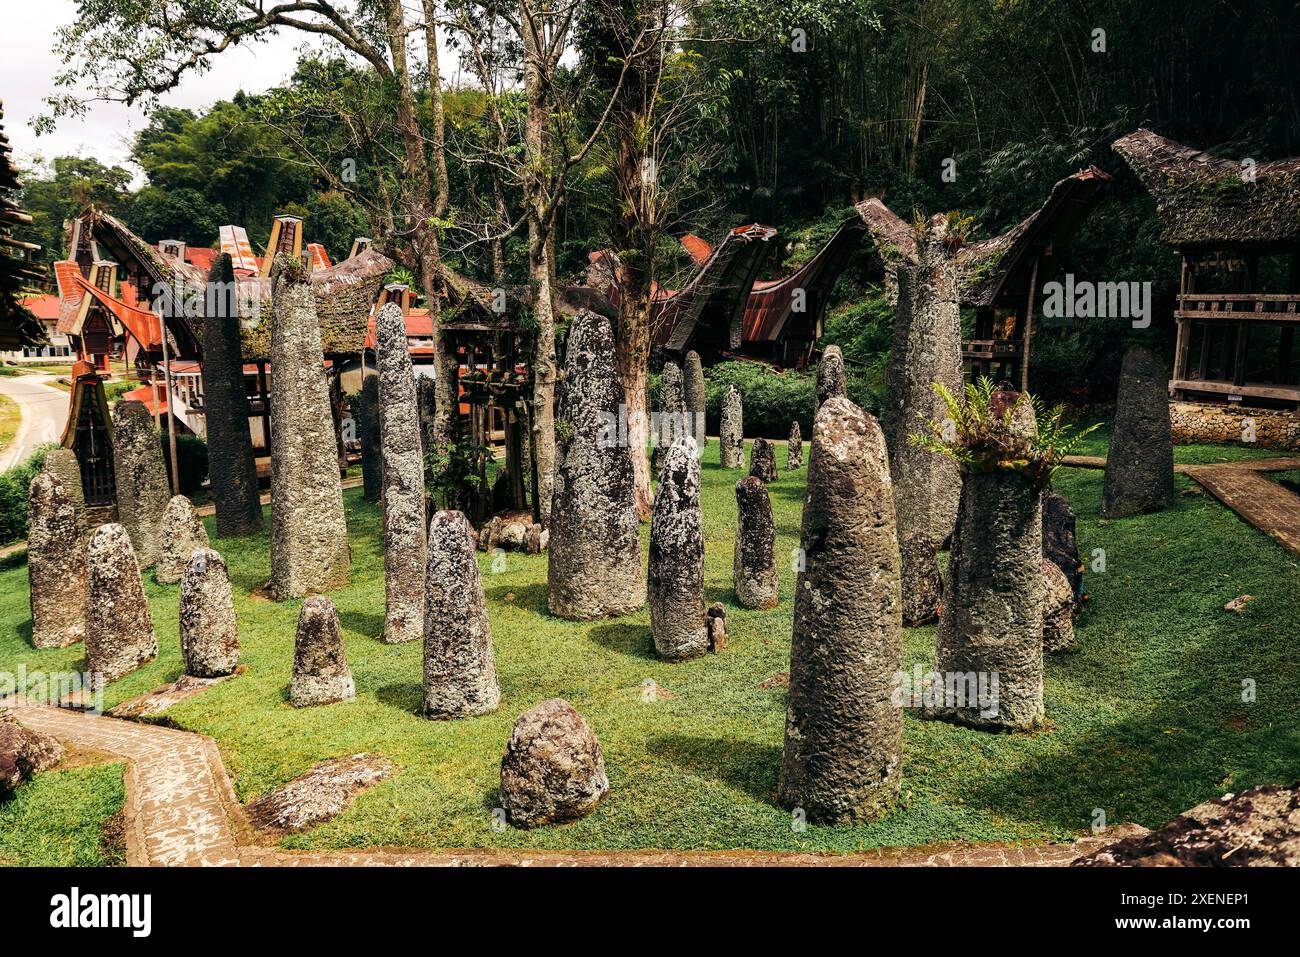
[[501, 698, 610, 828]]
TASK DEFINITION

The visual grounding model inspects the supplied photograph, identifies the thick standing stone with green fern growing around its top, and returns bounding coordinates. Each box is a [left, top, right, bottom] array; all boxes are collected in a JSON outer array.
[[927, 389, 1043, 729]]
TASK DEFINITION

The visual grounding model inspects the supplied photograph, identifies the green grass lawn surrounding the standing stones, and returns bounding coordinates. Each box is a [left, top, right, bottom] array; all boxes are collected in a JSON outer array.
[[0, 436, 1300, 852]]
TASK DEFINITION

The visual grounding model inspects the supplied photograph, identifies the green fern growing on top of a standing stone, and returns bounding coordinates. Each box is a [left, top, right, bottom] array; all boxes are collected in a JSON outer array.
[[907, 376, 1100, 489]]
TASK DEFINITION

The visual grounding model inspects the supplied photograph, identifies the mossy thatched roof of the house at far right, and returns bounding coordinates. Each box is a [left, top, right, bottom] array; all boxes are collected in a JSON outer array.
[[1112, 130, 1300, 246]]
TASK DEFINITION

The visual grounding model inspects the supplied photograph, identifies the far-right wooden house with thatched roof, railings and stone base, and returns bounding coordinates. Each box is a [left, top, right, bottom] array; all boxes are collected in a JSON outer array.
[[1113, 130, 1300, 449]]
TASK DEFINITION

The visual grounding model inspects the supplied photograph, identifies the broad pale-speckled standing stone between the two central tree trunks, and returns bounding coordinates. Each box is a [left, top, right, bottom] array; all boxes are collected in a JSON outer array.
[[546, 309, 646, 620]]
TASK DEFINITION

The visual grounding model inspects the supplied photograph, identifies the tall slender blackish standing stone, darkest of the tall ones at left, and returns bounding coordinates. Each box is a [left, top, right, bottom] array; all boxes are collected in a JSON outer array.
[[203, 254, 263, 538]]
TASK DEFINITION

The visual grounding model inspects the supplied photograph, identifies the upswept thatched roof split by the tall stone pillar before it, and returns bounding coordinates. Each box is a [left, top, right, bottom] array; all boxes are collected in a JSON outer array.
[[857, 166, 1110, 306]]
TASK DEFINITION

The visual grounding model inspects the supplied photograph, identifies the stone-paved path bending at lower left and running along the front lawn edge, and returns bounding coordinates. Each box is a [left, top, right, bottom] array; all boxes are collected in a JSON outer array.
[[0, 698, 1130, 867]]
